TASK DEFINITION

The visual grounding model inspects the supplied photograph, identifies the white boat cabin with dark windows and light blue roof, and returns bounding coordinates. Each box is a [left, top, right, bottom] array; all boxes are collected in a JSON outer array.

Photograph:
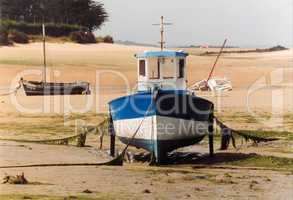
[[135, 51, 188, 91]]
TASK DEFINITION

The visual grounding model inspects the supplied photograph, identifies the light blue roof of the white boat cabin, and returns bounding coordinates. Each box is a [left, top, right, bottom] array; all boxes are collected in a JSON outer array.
[[135, 51, 188, 58]]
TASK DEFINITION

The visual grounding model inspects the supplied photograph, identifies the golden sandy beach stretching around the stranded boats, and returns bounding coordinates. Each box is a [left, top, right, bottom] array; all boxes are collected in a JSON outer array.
[[0, 43, 293, 200]]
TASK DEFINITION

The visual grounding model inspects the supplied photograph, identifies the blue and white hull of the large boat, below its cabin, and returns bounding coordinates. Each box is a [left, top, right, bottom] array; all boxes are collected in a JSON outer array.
[[109, 90, 213, 163]]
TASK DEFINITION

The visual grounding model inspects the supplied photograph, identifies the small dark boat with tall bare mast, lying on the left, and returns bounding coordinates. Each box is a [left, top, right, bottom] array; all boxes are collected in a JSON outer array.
[[20, 23, 91, 96]]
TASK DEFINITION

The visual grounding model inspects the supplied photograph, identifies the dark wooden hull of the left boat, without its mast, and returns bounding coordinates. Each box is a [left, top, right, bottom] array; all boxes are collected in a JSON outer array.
[[22, 81, 91, 96]]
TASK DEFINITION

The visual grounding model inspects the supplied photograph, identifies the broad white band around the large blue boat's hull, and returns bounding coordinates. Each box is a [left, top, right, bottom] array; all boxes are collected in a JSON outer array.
[[114, 116, 208, 140]]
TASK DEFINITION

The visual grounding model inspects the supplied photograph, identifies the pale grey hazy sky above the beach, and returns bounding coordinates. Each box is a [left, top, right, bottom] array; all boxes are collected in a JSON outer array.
[[96, 0, 293, 47]]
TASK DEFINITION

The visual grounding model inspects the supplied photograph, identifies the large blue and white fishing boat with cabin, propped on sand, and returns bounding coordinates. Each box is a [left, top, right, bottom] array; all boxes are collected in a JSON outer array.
[[109, 18, 214, 163]]
